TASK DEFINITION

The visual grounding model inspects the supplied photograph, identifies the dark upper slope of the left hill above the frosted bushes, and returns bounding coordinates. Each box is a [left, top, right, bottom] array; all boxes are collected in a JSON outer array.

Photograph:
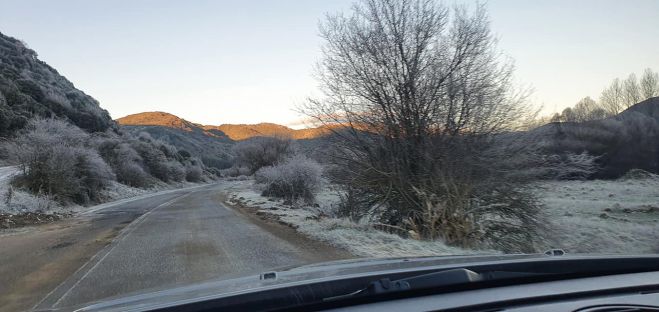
[[0, 33, 115, 137]]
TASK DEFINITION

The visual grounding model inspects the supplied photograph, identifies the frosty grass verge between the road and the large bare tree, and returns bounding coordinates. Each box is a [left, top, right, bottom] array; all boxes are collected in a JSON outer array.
[[228, 180, 482, 257]]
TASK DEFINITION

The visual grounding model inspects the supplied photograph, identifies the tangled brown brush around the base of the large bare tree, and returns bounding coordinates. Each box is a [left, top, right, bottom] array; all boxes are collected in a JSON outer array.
[[329, 135, 552, 252]]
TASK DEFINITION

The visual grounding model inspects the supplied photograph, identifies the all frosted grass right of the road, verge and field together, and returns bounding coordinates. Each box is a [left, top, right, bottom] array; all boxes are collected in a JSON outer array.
[[227, 176, 659, 257]]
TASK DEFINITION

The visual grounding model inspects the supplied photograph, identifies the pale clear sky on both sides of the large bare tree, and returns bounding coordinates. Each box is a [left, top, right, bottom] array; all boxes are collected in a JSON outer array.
[[0, 0, 659, 125]]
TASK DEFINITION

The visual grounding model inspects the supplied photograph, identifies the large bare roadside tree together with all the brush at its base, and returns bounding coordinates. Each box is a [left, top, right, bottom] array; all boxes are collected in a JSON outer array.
[[296, 0, 593, 251]]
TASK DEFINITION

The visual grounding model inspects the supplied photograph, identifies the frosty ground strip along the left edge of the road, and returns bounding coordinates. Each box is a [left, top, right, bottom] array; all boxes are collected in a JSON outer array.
[[0, 167, 206, 229]]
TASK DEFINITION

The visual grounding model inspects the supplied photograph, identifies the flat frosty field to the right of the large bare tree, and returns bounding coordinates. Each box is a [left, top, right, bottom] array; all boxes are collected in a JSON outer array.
[[536, 175, 659, 254]]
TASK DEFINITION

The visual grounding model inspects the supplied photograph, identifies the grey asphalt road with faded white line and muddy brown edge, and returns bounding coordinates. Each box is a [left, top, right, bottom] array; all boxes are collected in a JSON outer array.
[[0, 184, 350, 311]]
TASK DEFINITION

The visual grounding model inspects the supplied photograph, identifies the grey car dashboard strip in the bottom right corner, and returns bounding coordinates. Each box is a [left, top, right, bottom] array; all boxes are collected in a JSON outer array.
[[330, 272, 659, 312]]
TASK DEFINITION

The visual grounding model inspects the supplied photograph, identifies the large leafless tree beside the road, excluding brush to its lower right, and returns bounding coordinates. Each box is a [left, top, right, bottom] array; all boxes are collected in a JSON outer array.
[[303, 0, 544, 251]]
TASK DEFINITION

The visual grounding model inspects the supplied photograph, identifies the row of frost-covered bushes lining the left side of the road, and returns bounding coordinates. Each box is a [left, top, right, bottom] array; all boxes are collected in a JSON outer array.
[[3, 119, 210, 205]]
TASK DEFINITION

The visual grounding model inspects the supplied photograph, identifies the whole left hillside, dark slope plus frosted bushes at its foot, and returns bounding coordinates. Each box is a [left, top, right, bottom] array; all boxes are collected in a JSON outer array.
[[0, 34, 215, 217]]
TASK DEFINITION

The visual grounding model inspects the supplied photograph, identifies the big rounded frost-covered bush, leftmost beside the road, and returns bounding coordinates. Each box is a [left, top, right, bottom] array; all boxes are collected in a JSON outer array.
[[10, 119, 115, 204]]
